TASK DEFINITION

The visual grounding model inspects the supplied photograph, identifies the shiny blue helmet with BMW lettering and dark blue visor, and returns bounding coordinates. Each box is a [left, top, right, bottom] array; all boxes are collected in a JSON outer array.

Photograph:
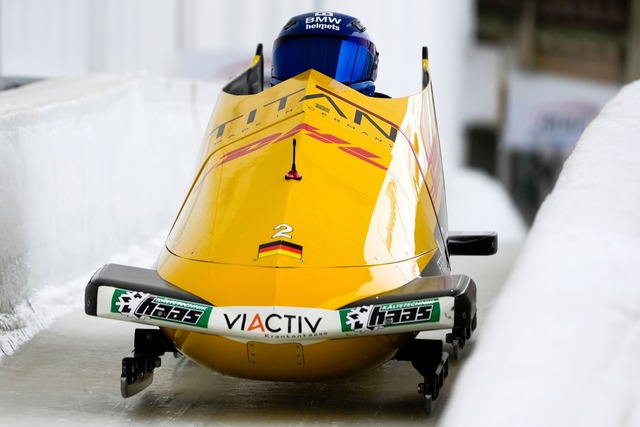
[[271, 12, 378, 96]]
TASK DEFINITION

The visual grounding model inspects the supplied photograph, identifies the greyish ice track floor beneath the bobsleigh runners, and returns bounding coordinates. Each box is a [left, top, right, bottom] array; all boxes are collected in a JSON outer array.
[[0, 244, 519, 426]]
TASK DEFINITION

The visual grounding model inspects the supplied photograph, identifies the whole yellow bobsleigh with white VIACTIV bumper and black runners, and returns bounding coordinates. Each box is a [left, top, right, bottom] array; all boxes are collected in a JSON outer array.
[[85, 47, 497, 412]]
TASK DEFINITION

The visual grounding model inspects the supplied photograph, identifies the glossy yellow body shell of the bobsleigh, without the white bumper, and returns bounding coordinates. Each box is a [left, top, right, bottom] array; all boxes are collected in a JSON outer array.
[[158, 70, 448, 380]]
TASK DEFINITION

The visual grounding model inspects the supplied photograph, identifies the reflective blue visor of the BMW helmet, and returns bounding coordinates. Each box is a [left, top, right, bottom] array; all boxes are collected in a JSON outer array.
[[272, 35, 377, 85]]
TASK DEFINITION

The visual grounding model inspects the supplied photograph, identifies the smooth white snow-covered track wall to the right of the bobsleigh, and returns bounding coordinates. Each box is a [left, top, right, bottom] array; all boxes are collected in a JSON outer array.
[[441, 82, 640, 426]]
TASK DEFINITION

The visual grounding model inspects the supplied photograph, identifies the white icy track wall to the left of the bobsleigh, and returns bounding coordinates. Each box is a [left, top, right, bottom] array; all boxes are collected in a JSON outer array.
[[0, 75, 219, 357]]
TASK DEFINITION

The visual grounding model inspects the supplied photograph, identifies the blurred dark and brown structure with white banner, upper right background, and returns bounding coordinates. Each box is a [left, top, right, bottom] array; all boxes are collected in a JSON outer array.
[[466, 0, 640, 222]]
